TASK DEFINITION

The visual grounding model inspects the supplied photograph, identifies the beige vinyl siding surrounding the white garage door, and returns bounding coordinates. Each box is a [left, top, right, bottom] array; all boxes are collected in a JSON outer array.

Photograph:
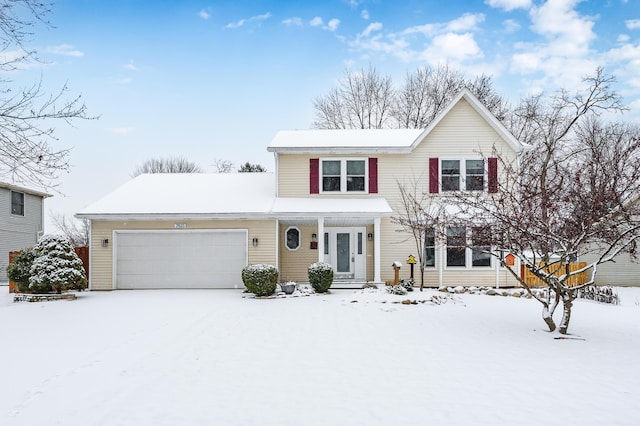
[[91, 220, 276, 290]]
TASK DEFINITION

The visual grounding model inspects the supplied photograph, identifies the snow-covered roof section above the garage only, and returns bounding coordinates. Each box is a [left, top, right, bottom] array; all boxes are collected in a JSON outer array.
[[77, 173, 275, 219]]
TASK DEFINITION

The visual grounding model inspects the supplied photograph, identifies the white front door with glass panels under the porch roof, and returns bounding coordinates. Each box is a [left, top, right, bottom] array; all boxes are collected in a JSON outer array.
[[324, 227, 367, 281]]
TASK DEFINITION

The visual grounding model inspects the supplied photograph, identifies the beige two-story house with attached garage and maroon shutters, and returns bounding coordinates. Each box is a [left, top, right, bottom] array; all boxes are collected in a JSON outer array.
[[77, 90, 524, 290]]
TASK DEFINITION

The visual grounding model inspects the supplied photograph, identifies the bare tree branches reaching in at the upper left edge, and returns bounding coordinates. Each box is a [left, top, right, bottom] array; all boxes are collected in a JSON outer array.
[[0, 0, 94, 188]]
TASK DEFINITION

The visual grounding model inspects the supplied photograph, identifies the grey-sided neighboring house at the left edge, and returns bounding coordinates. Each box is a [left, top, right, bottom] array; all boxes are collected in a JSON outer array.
[[0, 182, 50, 282]]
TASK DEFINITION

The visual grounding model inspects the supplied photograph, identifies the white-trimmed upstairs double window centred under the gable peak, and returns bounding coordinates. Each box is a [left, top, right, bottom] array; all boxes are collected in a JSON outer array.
[[440, 159, 486, 192]]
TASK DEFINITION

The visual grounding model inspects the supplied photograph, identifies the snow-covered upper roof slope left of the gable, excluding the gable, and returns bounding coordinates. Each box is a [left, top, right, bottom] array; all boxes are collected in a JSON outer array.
[[267, 129, 423, 153]]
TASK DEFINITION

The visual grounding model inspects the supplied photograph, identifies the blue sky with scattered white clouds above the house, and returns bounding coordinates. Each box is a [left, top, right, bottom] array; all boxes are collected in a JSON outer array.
[[12, 0, 640, 231]]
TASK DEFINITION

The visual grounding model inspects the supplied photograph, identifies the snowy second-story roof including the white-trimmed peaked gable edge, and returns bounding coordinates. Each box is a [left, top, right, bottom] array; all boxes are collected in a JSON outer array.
[[267, 89, 527, 154]]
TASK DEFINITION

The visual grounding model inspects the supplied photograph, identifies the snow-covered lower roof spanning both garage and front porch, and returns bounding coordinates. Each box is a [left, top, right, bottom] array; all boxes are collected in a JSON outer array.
[[76, 173, 391, 220]]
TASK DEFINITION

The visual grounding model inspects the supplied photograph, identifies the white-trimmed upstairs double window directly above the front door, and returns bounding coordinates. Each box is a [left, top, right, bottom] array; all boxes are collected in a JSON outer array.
[[321, 159, 367, 192]]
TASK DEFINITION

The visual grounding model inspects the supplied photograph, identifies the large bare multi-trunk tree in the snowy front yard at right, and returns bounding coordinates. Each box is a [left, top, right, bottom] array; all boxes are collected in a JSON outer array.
[[448, 69, 640, 334]]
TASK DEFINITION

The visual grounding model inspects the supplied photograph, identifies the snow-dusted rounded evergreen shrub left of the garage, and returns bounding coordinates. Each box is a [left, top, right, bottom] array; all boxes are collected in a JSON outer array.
[[29, 235, 87, 293]]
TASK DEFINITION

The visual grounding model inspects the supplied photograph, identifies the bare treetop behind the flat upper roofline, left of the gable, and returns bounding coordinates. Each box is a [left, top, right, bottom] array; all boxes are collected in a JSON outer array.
[[313, 66, 394, 129]]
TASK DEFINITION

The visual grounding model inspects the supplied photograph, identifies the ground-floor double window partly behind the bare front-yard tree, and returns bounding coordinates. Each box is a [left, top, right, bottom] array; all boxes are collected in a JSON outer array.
[[445, 227, 492, 268]]
